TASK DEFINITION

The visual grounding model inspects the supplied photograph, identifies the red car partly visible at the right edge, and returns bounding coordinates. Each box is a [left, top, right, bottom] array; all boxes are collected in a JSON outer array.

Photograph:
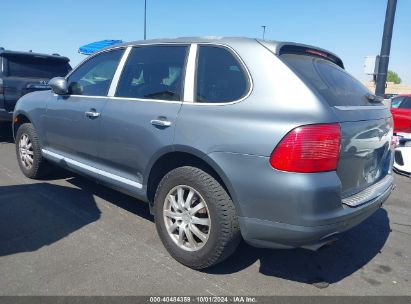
[[391, 94, 411, 133]]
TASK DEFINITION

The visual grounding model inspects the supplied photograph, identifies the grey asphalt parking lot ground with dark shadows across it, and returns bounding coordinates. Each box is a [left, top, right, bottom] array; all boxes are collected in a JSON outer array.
[[0, 125, 411, 295]]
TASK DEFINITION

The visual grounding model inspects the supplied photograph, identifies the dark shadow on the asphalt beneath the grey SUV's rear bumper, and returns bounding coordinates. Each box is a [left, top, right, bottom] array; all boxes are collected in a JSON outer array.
[[205, 209, 390, 288]]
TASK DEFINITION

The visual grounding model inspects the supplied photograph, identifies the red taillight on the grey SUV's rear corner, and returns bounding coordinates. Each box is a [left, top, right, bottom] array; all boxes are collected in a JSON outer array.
[[270, 124, 341, 173]]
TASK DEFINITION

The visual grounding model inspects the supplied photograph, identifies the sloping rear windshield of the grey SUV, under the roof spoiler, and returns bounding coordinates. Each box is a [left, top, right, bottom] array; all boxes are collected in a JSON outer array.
[[280, 54, 372, 106]]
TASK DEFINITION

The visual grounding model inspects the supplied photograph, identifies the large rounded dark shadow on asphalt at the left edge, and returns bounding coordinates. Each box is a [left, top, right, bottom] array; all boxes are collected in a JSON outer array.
[[0, 183, 100, 256]]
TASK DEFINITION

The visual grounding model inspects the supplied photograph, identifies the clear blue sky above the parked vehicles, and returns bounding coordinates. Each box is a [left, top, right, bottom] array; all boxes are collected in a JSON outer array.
[[0, 0, 411, 84]]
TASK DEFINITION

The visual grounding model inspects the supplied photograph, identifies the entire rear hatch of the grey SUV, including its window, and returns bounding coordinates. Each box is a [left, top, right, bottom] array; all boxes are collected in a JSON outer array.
[[279, 46, 393, 198]]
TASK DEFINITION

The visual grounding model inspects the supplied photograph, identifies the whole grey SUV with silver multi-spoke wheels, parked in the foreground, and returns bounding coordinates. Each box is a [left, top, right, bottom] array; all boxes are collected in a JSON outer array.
[[13, 38, 393, 269]]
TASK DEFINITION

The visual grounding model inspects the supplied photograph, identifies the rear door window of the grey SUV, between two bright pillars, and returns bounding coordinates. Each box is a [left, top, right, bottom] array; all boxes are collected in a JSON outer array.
[[115, 45, 187, 100]]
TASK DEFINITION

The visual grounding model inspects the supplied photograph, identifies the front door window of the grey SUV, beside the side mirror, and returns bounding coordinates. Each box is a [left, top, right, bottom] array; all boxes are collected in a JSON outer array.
[[67, 49, 124, 96]]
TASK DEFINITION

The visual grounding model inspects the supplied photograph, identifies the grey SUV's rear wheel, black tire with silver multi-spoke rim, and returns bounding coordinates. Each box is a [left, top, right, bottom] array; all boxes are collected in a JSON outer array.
[[154, 166, 241, 269]]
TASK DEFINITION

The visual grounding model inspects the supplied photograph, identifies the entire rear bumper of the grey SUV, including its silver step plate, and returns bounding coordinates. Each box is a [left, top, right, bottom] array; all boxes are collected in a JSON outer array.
[[210, 152, 394, 249]]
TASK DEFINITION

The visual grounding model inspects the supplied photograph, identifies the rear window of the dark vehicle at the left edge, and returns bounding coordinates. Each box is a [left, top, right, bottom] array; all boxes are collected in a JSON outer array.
[[7, 56, 71, 78]]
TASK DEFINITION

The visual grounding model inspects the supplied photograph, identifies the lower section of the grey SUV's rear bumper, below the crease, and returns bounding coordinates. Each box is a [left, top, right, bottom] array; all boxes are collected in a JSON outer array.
[[240, 185, 394, 250]]
